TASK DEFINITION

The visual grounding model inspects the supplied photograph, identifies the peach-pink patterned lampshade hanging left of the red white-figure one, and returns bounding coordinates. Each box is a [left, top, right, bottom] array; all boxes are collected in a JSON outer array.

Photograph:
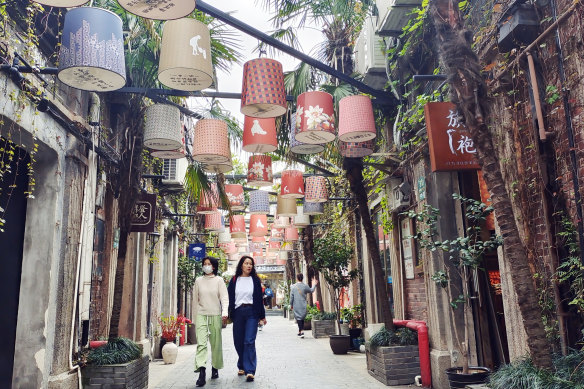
[[193, 119, 231, 165]]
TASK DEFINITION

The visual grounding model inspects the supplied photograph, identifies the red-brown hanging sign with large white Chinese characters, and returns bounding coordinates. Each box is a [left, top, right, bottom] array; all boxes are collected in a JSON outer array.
[[424, 103, 480, 172]]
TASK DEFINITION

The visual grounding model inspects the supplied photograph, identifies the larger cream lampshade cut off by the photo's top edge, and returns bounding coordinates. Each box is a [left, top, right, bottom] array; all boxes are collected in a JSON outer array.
[[118, 0, 195, 19]]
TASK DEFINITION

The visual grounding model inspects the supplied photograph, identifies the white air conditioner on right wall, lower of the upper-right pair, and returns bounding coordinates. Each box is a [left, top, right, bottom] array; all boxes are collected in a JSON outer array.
[[355, 17, 387, 89]]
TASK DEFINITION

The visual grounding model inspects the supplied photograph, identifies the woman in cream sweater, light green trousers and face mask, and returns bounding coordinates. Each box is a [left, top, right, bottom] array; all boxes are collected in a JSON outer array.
[[193, 257, 229, 386]]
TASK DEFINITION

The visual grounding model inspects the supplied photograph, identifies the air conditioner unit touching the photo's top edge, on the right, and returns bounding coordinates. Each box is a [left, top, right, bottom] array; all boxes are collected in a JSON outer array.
[[375, 0, 422, 36]]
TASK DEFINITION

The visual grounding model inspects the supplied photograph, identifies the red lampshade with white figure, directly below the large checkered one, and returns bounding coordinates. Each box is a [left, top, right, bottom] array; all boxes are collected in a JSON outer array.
[[243, 116, 278, 153]]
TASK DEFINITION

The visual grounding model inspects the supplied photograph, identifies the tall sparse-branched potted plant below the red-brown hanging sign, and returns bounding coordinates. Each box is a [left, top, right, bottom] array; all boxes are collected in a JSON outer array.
[[406, 193, 503, 387]]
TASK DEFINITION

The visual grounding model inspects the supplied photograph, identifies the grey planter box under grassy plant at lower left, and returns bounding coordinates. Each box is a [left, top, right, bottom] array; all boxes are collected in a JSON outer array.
[[81, 355, 150, 389]]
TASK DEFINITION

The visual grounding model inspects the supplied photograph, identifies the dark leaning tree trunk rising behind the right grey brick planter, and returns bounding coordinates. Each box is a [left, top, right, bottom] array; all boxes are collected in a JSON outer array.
[[343, 158, 394, 330]]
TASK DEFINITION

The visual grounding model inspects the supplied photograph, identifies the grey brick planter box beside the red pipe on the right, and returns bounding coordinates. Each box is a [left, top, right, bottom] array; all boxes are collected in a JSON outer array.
[[366, 345, 420, 386]]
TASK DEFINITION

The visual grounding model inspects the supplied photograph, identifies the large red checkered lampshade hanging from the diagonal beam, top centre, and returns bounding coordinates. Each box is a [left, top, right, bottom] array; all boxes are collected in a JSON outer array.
[[241, 58, 286, 118]]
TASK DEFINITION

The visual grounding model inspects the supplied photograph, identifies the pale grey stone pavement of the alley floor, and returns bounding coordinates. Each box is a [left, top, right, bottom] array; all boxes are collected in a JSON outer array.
[[149, 316, 415, 389]]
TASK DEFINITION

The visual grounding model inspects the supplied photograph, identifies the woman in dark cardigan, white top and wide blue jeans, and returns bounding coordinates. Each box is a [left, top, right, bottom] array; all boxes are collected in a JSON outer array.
[[227, 255, 267, 382]]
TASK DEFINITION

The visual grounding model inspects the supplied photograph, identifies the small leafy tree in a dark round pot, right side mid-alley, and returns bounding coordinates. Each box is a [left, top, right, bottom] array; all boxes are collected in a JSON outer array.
[[313, 229, 359, 354]]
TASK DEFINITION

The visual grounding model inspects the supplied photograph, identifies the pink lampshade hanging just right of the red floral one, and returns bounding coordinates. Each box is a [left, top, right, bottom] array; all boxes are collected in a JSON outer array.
[[339, 95, 377, 142]]
